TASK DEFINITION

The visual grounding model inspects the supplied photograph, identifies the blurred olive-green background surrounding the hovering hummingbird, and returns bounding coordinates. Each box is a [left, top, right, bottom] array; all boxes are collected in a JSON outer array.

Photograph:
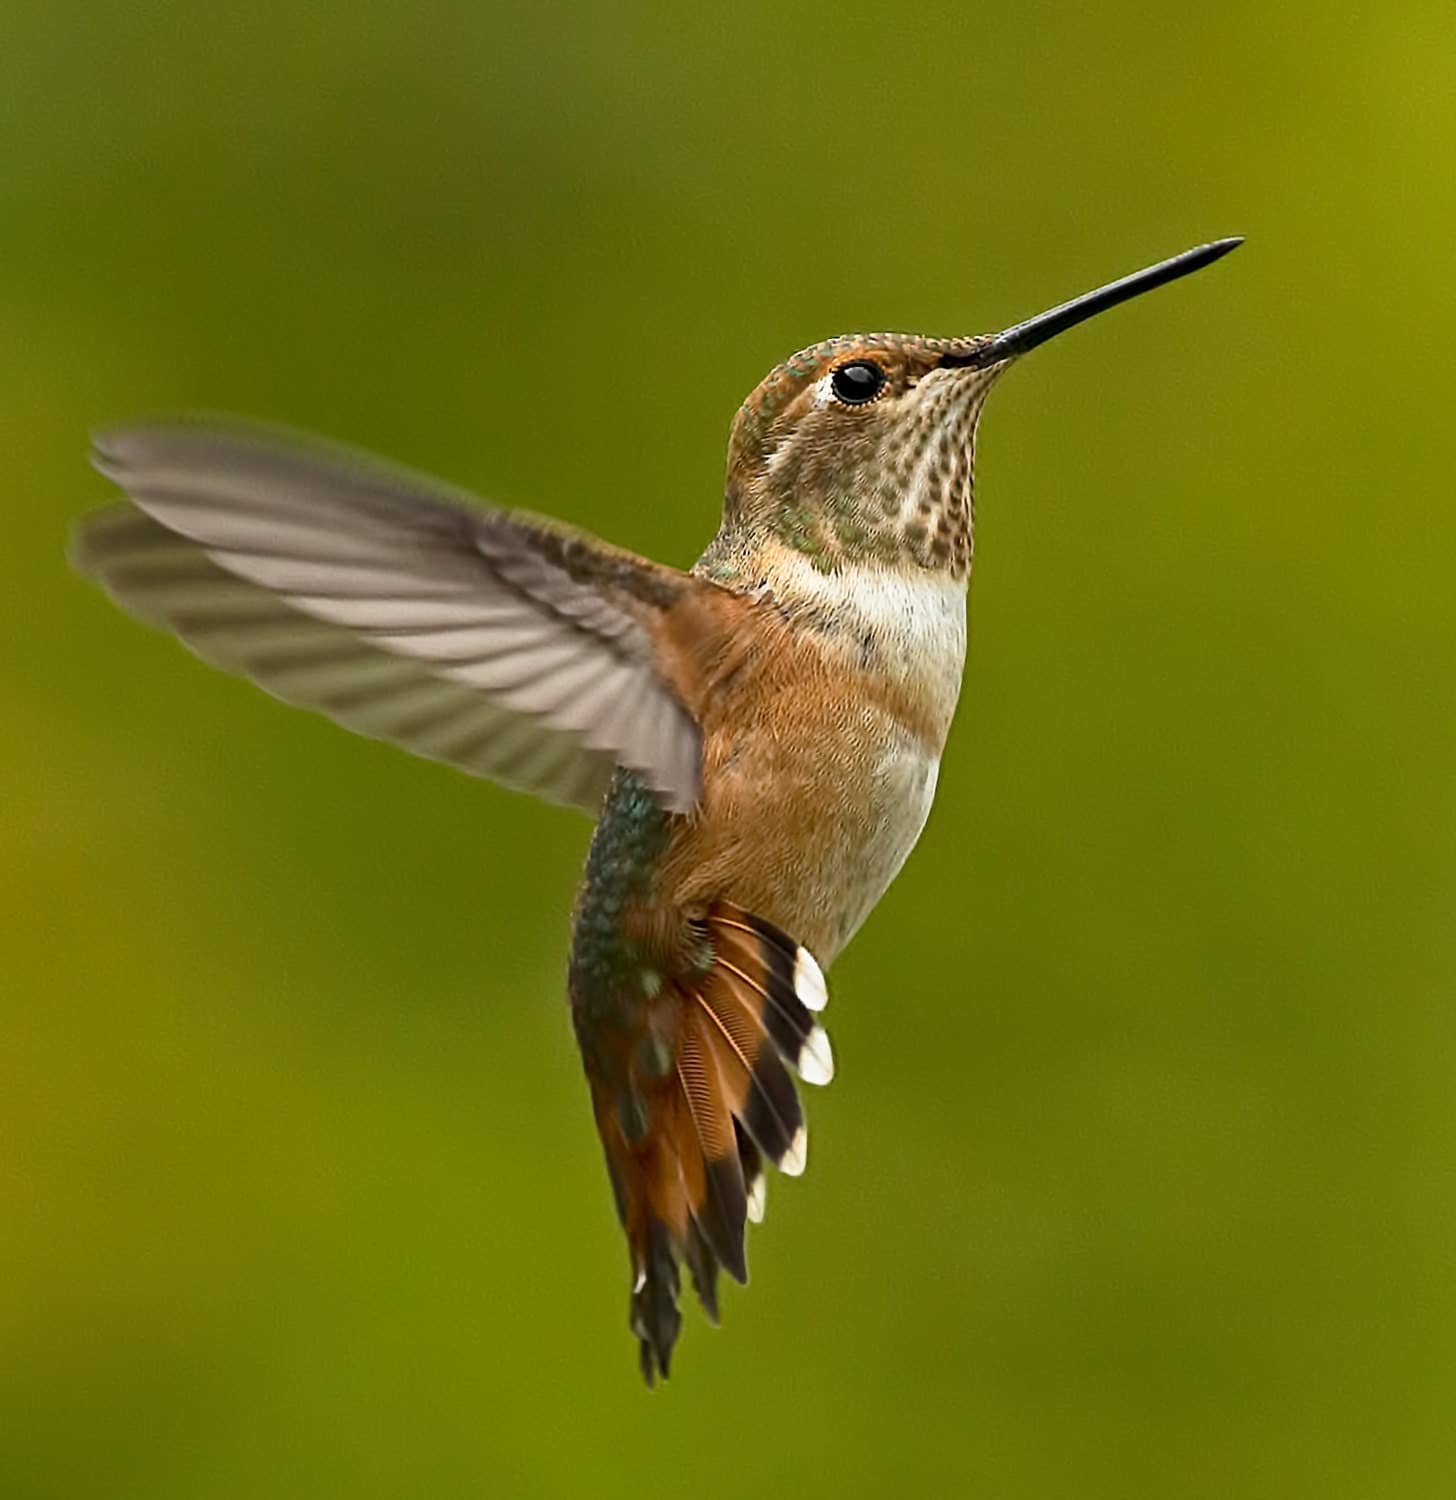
[[0, 0, 1456, 1500]]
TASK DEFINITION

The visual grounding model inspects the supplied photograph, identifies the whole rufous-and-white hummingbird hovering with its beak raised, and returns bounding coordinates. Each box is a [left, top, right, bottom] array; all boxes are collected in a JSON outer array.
[[70, 239, 1242, 1385]]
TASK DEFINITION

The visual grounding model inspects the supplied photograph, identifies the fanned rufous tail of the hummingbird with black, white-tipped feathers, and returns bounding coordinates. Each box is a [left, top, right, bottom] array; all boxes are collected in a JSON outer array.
[[595, 903, 834, 1385]]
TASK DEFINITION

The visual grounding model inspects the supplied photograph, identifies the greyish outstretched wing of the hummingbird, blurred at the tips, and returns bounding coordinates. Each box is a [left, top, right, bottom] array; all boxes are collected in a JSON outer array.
[[72, 425, 705, 813]]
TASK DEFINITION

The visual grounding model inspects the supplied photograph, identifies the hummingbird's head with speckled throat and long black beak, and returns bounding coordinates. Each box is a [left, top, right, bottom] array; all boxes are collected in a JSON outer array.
[[723, 239, 1240, 578]]
